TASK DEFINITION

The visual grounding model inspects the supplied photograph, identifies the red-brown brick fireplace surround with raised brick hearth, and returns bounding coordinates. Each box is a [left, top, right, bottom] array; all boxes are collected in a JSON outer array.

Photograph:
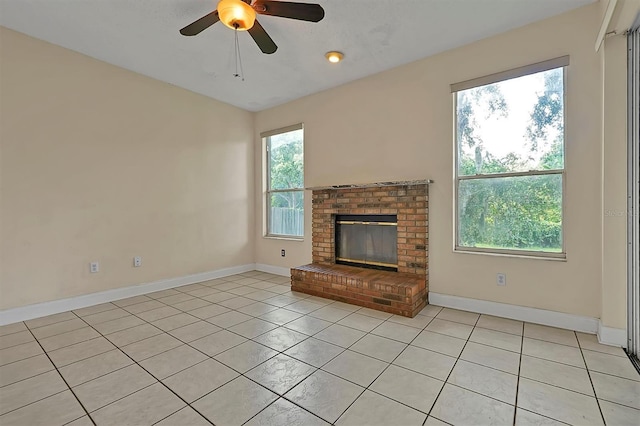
[[291, 181, 429, 317]]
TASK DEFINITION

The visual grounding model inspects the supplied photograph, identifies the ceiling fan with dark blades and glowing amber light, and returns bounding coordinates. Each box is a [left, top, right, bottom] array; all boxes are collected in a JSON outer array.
[[180, 0, 324, 54]]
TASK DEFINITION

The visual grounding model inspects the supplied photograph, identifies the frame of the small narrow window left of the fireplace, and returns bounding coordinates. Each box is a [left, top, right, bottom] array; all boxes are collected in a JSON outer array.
[[260, 123, 305, 241]]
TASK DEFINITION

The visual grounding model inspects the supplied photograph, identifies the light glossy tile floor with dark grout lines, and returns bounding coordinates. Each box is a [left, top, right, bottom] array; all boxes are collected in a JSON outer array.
[[0, 271, 640, 426]]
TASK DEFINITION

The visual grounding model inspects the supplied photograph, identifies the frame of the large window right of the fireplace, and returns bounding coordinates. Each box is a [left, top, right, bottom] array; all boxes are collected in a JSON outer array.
[[451, 56, 569, 261]]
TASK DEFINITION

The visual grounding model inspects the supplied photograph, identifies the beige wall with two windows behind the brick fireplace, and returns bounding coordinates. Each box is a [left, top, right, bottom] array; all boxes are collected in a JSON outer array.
[[255, 3, 608, 320]]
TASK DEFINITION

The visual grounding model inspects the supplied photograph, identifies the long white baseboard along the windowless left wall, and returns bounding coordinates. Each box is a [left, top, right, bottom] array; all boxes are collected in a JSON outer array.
[[0, 263, 258, 325]]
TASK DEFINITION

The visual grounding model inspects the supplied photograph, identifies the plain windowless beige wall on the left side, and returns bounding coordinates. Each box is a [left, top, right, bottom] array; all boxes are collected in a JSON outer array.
[[0, 28, 255, 309]]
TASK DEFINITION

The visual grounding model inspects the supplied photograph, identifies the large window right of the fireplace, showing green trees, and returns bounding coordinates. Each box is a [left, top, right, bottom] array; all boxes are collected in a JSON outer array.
[[452, 57, 569, 257]]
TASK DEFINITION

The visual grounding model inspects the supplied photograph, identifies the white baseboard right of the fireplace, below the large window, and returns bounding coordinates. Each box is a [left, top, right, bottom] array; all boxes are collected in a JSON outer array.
[[429, 292, 600, 334]]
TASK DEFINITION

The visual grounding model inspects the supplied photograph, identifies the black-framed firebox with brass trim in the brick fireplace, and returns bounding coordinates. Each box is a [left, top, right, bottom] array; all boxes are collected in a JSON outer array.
[[335, 215, 398, 271]]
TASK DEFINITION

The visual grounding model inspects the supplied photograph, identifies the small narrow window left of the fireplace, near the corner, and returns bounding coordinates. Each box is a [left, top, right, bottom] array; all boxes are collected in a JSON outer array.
[[262, 125, 304, 238]]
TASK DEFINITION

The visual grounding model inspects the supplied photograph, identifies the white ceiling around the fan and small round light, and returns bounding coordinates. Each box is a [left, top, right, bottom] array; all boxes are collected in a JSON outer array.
[[0, 0, 597, 111]]
